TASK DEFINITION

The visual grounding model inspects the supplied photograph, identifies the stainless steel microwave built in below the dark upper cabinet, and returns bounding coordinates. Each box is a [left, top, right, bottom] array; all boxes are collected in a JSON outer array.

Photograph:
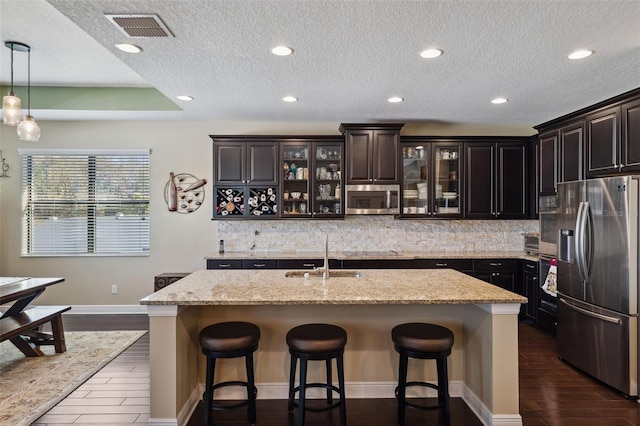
[[345, 185, 400, 215]]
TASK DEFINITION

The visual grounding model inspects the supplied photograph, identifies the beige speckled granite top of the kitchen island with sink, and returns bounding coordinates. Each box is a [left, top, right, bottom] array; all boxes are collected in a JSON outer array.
[[140, 269, 527, 306]]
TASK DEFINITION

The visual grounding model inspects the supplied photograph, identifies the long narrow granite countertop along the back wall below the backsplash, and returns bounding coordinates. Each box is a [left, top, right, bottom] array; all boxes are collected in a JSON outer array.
[[205, 250, 538, 262]]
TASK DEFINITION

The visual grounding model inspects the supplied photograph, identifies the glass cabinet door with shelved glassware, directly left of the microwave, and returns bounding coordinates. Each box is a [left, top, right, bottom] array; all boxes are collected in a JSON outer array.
[[312, 142, 344, 218]]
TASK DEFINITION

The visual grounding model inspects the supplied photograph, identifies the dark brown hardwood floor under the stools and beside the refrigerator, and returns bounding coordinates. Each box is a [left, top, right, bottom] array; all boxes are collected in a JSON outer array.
[[53, 315, 640, 426]]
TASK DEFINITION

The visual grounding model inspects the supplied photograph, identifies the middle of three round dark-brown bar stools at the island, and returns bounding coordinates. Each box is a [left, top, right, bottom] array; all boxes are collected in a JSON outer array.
[[287, 324, 347, 426]]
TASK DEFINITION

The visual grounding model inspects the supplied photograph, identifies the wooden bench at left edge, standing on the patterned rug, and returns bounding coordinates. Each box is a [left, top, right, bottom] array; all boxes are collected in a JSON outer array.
[[0, 306, 71, 356]]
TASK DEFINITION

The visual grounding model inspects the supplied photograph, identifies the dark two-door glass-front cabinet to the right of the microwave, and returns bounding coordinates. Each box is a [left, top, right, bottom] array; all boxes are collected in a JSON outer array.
[[401, 138, 462, 217]]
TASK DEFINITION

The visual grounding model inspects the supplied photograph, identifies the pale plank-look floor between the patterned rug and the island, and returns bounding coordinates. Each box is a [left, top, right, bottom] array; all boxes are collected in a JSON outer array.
[[33, 334, 150, 426]]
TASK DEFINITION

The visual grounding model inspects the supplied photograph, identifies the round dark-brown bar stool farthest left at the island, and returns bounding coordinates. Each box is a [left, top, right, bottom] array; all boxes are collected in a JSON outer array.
[[199, 322, 260, 425]]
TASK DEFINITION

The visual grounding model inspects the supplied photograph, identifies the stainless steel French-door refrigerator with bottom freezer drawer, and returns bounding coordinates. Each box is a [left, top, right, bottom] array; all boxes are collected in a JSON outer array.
[[557, 176, 640, 397]]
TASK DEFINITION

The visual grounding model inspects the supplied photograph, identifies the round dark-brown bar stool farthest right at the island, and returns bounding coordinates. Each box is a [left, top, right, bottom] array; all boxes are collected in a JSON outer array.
[[391, 322, 453, 426]]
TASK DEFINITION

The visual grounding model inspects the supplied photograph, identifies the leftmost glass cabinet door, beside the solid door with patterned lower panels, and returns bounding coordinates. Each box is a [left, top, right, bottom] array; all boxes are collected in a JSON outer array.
[[281, 142, 311, 218]]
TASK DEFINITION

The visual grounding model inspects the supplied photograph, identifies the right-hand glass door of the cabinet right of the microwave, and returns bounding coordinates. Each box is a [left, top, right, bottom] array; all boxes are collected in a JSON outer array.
[[433, 144, 462, 216]]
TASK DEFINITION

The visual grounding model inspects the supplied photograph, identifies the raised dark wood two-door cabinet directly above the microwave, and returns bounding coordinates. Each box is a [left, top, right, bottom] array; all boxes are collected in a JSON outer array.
[[340, 123, 404, 185]]
